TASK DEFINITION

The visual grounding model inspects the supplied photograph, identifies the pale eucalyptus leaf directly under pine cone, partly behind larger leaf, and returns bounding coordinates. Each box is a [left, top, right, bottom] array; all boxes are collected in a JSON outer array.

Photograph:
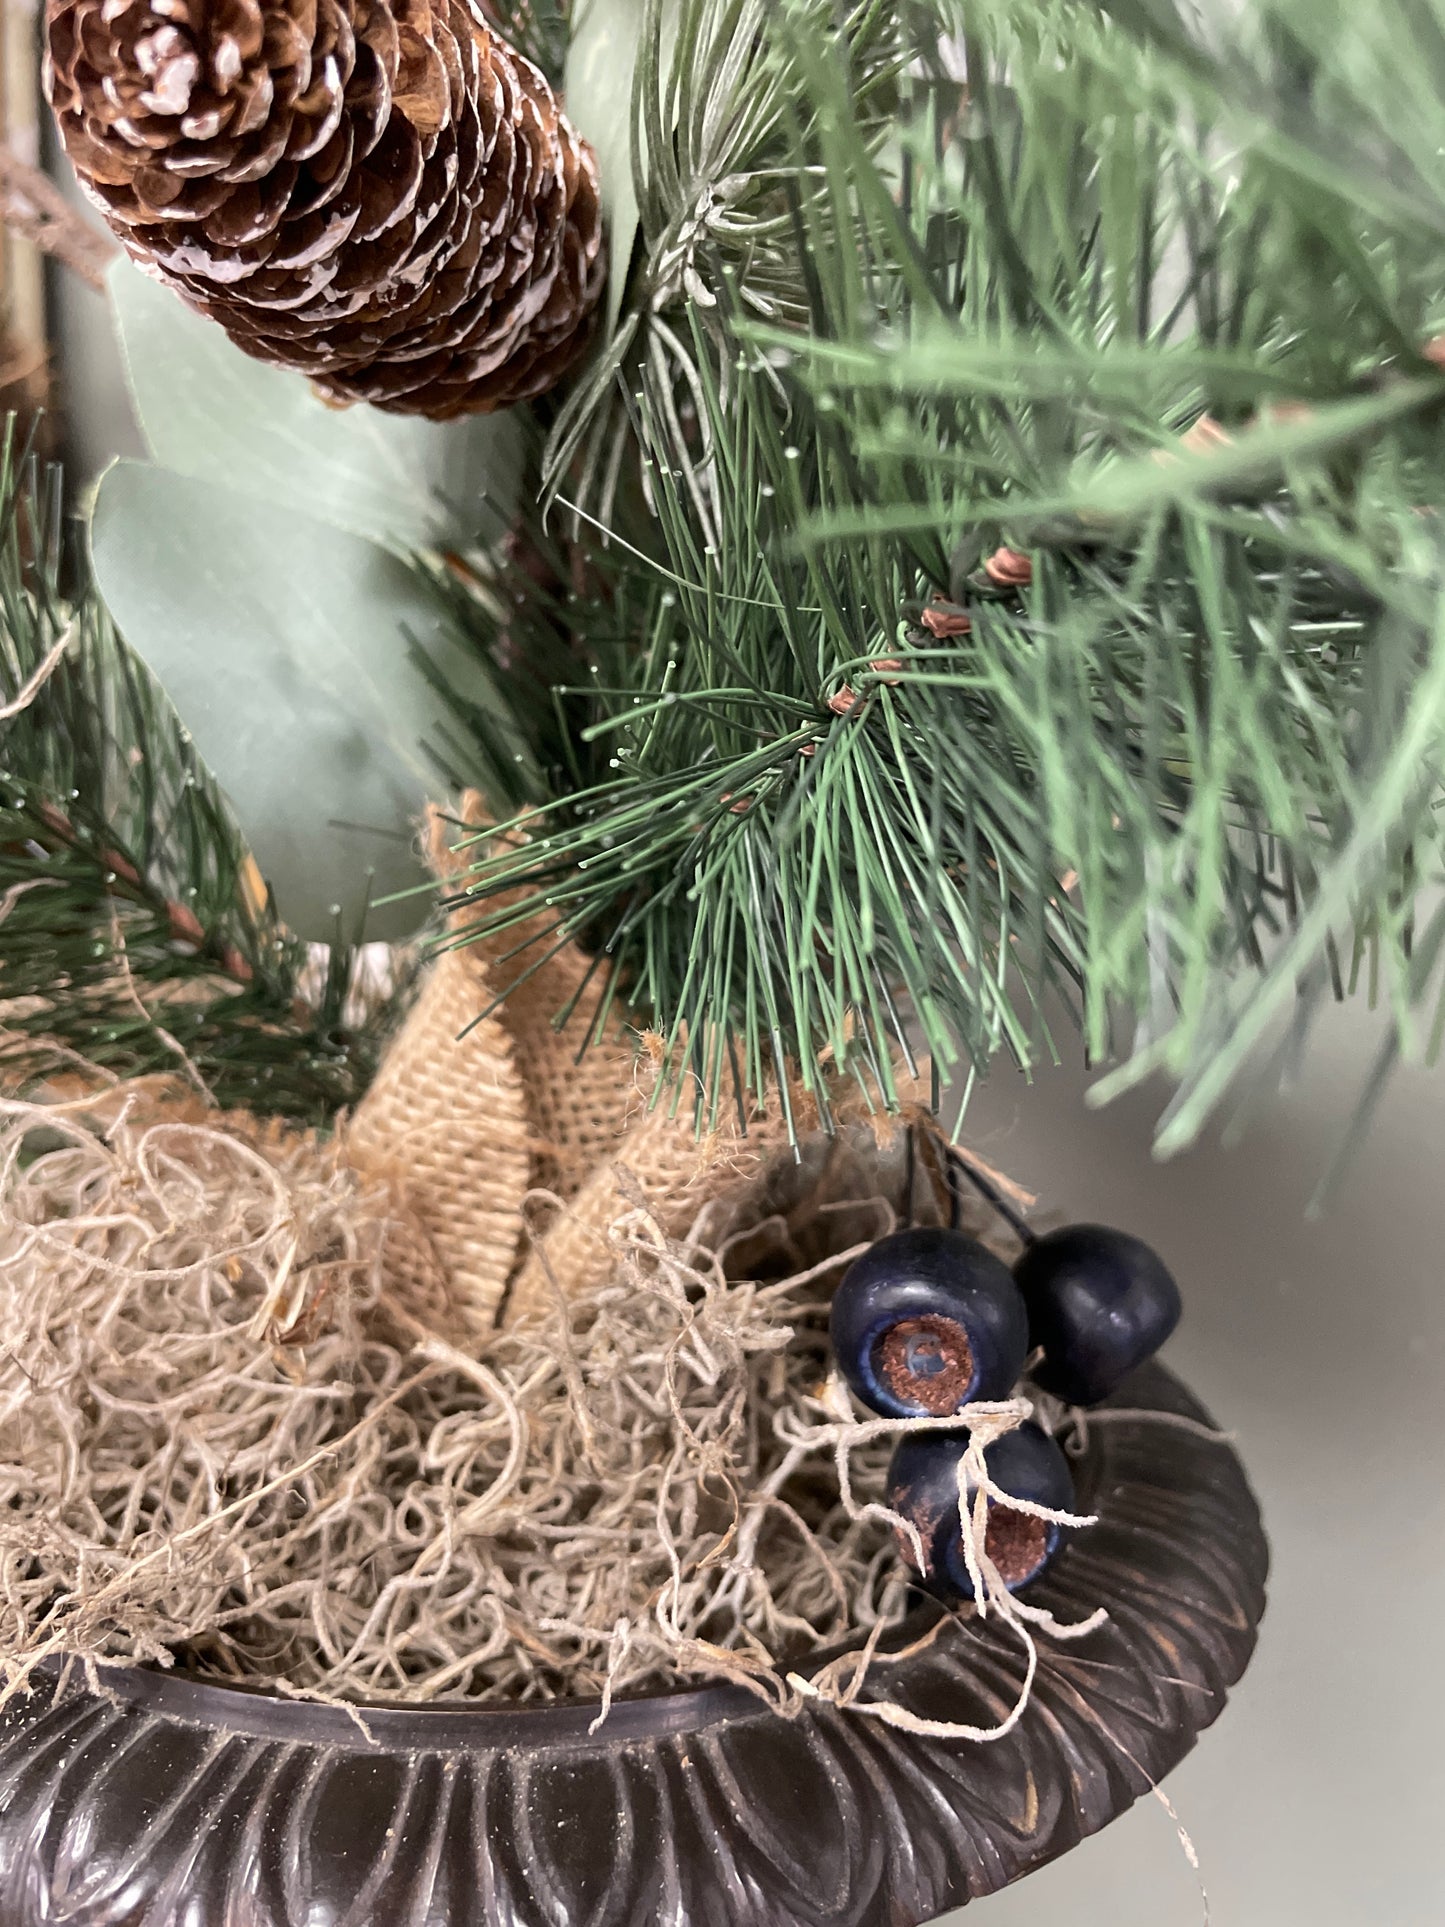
[[108, 256, 522, 549]]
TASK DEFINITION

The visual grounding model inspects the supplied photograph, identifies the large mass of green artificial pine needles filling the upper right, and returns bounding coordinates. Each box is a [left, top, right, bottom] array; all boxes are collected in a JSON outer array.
[[439, 0, 1445, 1143]]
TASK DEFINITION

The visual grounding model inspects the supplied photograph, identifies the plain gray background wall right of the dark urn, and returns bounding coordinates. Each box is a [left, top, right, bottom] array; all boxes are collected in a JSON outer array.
[[932, 1008, 1445, 1927]]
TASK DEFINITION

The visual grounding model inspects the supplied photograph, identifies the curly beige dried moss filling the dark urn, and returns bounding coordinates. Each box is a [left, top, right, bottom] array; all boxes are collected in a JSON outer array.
[[0, 1089, 1040, 1702]]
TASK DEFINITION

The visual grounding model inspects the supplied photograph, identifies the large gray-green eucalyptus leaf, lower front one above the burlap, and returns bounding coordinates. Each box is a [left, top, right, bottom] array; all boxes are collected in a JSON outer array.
[[91, 450, 493, 940]]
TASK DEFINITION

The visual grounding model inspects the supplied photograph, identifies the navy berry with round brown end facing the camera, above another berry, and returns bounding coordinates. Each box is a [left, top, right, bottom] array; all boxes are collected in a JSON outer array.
[[832, 1227, 1029, 1418]]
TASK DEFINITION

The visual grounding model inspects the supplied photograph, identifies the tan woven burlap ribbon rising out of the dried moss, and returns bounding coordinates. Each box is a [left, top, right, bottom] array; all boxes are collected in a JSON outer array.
[[347, 794, 813, 1328]]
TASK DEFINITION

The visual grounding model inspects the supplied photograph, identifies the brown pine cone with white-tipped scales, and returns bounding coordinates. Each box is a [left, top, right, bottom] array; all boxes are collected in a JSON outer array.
[[46, 0, 603, 420]]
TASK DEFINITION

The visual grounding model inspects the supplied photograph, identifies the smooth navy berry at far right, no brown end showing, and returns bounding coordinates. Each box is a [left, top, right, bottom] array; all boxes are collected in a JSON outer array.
[[1013, 1224, 1181, 1405]]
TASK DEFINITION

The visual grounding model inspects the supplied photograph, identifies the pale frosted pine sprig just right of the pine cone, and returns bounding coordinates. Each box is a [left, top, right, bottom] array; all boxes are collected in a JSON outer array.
[[543, 0, 907, 520]]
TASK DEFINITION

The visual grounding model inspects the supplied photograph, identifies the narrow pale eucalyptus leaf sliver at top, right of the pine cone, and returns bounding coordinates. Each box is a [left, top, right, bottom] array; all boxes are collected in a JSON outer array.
[[563, 0, 678, 335]]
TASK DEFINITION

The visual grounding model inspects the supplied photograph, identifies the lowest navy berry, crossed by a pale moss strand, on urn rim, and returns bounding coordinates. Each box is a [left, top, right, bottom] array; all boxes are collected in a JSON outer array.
[[888, 1424, 1073, 1599]]
